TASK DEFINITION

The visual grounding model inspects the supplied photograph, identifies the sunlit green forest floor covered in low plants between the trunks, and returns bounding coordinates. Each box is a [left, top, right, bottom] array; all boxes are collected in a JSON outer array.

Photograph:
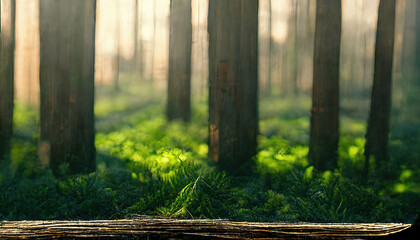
[[0, 75, 420, 223]]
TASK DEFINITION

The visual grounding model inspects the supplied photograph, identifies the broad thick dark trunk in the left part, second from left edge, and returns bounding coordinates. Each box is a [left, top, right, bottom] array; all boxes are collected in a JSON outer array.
[[40, 0, 96, 176]]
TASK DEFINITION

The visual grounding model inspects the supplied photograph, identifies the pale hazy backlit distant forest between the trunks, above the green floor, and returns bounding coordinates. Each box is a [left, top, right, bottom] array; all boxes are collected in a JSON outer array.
[[15, 0, 416, 105]]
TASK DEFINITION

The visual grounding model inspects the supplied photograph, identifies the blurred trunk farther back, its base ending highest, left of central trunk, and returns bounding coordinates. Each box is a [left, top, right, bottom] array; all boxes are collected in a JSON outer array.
[[166, 0, 192, 122]]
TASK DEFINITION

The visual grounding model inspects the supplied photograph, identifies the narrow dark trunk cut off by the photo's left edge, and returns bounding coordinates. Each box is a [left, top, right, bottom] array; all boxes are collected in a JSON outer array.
[[0, 0, 16, 159]]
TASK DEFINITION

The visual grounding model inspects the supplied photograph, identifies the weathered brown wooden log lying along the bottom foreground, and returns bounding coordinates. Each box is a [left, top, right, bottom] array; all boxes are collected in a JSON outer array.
[[0, 217, 414, 239]]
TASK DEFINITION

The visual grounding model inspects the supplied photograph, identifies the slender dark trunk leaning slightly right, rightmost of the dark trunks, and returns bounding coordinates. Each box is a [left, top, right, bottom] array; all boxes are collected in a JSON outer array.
[[365, 0, 395, 173]]
